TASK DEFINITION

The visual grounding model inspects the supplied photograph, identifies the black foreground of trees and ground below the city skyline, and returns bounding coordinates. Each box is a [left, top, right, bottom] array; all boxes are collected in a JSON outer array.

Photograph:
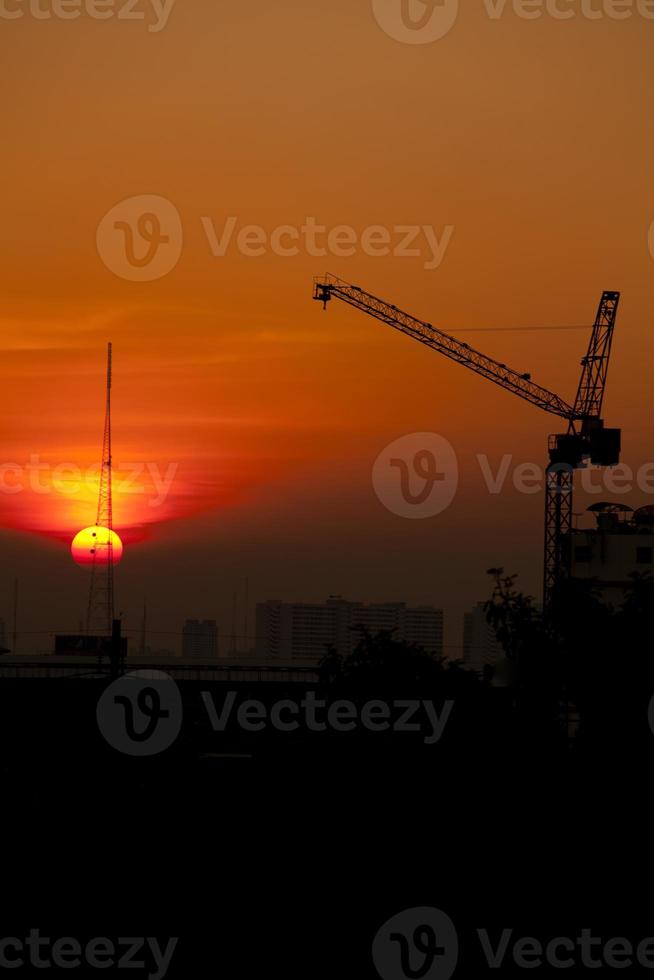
[[0, 570, 654, 978]]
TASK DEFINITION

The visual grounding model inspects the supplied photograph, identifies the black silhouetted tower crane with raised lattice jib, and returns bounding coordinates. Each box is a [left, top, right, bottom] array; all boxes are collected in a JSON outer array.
[[313, 275, 621, 609]]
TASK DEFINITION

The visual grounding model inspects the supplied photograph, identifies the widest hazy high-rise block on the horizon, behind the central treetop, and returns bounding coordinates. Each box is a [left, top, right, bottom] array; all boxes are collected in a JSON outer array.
[[256, 597, 443, 662]]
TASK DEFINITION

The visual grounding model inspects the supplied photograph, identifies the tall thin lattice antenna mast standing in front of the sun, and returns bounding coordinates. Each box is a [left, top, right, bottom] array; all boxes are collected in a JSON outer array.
[[86, 344, 114, 635]]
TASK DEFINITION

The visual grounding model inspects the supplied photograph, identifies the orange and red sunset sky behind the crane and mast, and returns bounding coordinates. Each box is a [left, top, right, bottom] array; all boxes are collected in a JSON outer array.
[[0, 0, 654, 652]]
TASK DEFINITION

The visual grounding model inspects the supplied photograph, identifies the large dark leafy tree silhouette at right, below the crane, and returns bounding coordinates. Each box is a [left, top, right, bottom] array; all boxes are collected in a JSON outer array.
[[485, 568, 654, 752]]
